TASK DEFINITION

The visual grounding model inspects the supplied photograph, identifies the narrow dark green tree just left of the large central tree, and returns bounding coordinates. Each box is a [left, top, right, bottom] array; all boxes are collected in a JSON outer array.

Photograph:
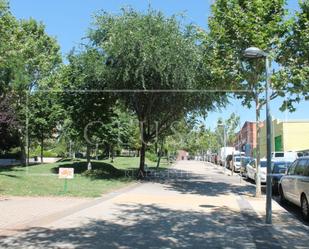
[[60, 48, 114, 170]]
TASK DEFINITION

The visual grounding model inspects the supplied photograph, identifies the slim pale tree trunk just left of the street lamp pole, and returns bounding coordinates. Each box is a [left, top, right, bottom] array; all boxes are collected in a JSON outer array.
[[255, 96, 262, 197]]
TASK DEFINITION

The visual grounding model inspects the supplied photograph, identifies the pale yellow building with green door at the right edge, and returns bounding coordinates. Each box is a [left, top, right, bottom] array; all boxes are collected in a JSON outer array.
[[261, 119, 309, 157]]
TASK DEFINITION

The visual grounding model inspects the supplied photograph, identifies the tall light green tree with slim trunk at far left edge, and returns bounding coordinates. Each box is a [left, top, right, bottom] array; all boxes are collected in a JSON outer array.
[[0, 0, 61, 162]]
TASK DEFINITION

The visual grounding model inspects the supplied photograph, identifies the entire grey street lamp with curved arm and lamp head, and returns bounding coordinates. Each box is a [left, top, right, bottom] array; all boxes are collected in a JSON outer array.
[[244, 47, 272, 224]]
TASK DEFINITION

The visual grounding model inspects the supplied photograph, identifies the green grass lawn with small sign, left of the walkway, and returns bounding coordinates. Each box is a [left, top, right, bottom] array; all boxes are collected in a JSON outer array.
[[0, 157, 168, 197]]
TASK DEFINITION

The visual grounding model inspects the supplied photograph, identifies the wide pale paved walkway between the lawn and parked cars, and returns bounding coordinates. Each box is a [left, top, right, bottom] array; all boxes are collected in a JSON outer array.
[[0, 161, 309, 249]]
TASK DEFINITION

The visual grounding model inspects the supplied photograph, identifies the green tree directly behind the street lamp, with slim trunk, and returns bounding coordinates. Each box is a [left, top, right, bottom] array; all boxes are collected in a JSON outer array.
[[205, 0, 290, 196]]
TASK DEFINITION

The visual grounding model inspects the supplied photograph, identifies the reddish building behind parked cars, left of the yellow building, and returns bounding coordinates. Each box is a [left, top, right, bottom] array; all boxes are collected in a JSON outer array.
[[234, 121, 256, 156]]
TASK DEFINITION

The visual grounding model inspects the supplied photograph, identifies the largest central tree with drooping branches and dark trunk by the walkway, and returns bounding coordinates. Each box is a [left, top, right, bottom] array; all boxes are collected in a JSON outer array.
[[89, 9, 221, 175]]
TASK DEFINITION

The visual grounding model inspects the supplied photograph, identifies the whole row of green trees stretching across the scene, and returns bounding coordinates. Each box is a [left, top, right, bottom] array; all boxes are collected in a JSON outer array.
[[0, 0, 309, 175]]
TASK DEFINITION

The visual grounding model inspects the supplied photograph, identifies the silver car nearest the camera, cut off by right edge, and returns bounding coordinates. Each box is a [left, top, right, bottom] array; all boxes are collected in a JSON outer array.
[[279, 156, 309, 220]]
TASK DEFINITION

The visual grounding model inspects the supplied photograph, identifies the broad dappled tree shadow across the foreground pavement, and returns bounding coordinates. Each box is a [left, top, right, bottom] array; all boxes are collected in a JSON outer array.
[[0, 204, 308, 249]]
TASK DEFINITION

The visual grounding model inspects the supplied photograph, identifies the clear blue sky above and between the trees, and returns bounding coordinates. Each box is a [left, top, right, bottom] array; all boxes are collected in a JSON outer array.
[[10, 0, 309, 127]]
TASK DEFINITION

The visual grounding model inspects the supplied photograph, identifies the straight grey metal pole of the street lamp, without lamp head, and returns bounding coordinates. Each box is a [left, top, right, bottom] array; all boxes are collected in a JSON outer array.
[[265, 56, 272, 224]]
